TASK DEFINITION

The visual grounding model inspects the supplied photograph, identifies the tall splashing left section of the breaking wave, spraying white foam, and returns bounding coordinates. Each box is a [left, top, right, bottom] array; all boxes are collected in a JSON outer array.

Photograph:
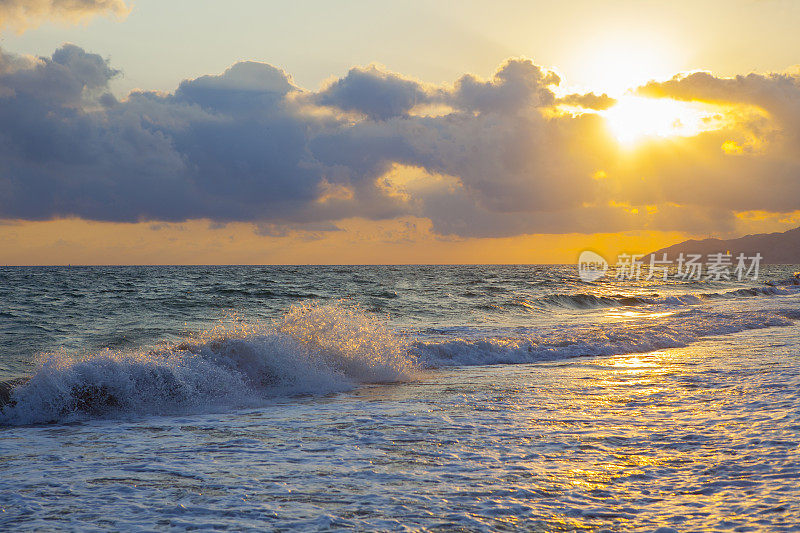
[[0, 304, 416, 424]]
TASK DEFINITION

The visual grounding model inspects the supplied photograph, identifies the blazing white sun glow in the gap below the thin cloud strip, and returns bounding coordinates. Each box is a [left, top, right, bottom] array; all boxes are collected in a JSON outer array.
[[603, 95, 713, 146]]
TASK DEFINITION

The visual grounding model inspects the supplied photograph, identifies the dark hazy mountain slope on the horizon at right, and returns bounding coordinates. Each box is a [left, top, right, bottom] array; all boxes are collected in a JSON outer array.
[[646, 228, 800, 264]]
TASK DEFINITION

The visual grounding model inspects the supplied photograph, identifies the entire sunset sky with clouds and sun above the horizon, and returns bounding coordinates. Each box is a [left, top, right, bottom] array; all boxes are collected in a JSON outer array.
[[0, 0, 800, 265]]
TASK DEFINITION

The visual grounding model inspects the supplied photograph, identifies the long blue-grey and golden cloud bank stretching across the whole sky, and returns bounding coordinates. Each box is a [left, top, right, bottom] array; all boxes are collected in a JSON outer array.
[[0, 44, 800, 237]]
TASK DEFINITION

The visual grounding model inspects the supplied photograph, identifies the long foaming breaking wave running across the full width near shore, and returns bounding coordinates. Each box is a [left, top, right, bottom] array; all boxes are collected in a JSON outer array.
[[0, 296, 800, 425]]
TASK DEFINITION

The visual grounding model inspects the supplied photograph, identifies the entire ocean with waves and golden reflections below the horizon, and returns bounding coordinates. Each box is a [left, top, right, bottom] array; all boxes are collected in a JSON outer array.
[[0, 265, 800, 531]]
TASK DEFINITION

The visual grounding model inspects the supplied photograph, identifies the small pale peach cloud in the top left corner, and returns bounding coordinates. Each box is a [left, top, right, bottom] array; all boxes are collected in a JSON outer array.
[[0, 0, 129, 32]]
